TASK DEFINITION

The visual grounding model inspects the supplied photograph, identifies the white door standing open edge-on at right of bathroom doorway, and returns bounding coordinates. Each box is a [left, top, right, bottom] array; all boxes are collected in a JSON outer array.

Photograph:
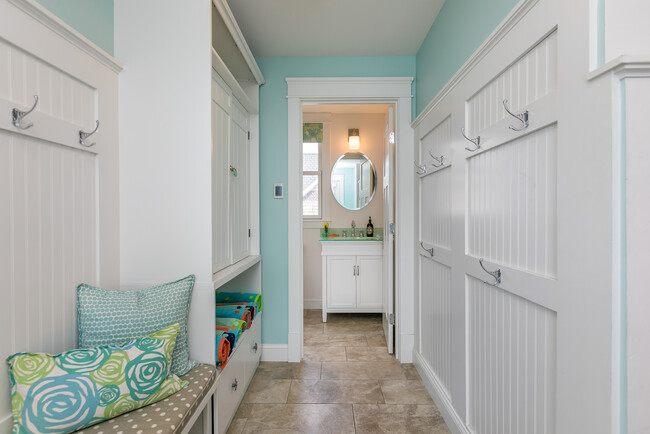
[[382, 106, 395, 354]]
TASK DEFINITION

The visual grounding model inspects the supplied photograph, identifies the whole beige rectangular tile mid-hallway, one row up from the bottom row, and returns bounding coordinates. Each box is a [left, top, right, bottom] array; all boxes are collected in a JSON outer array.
[[287, 380, 384, 404]]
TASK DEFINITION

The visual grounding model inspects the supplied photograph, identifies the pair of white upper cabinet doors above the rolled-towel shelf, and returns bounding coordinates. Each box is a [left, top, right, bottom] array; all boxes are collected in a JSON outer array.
[[212, 69, 250, 273]]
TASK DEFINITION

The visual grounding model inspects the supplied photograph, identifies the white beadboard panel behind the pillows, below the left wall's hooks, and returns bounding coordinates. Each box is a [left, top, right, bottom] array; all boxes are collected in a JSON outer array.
[[0, 130, 98, 357]]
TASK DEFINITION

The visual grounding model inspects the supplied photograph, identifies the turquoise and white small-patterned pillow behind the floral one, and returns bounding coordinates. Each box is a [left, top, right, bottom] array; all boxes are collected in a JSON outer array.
[[77, 275, 198, 377]]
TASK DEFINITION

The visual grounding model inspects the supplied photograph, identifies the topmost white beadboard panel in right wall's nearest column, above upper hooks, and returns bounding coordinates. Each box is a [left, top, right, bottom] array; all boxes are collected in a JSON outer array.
[[466, 31, 557, 137]]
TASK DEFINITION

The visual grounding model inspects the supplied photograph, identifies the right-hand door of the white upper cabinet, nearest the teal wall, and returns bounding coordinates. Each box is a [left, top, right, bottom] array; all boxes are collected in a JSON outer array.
[[229, 98, 249, 263]]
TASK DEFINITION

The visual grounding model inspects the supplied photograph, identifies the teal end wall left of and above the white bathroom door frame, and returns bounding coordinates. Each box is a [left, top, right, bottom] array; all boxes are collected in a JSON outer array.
[[256, 56, 415, 344]]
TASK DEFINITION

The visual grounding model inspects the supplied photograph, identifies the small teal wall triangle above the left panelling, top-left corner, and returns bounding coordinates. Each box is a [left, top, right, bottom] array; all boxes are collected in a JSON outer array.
[[36, 0, 112, 56]]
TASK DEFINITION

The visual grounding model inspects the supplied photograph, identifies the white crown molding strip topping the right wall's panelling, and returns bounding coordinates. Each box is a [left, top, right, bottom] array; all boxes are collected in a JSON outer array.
[[411, 0, 539, 128]]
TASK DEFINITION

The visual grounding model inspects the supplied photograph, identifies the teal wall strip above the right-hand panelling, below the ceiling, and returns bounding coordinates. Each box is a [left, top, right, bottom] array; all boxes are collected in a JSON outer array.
[[415, 0, 518, 114]]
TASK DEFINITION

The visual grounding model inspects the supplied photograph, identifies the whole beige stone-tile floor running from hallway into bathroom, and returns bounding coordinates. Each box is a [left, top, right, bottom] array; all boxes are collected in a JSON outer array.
[[228, 310, 450, 434]]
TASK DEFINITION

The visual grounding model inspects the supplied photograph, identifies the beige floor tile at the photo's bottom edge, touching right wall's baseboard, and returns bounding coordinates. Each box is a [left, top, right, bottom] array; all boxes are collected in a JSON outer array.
[[353, 404, 451, 434]]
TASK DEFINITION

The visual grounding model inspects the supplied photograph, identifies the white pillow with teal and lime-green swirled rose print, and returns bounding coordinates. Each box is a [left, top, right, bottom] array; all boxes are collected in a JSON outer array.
[[7, 324, 187, 433]]
